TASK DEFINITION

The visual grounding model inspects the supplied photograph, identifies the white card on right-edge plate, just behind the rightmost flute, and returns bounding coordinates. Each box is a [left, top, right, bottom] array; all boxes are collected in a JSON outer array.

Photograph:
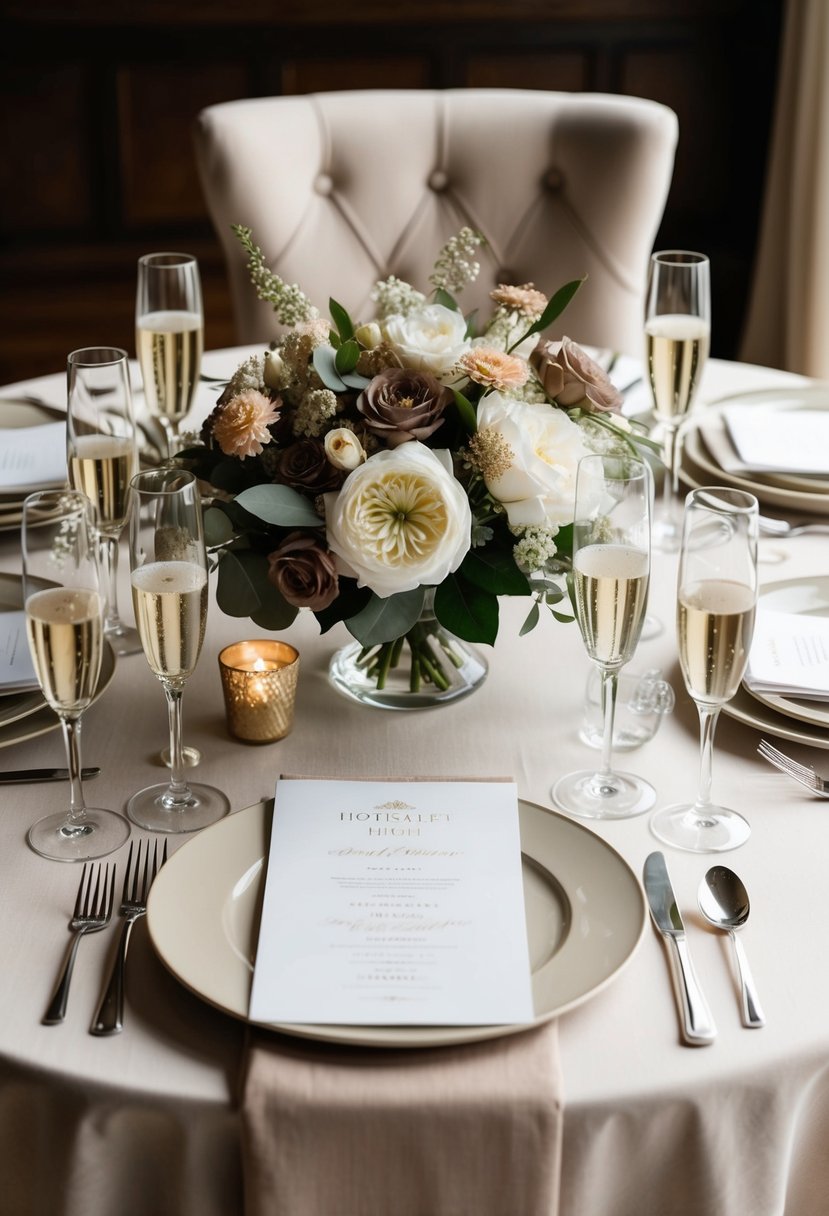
[[745, 609, 829, 700]]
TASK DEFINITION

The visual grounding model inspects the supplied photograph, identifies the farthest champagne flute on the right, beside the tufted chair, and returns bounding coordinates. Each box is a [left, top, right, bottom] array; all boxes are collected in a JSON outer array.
[[644, 249, 711, 553]]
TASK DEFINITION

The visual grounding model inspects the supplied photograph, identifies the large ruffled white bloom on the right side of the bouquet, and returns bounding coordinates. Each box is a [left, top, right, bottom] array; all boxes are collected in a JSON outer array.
[[478, 393, 591, 528]]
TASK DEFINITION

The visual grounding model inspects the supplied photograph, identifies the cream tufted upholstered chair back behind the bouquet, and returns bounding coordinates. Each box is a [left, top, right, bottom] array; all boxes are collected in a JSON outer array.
[[196, 89, 677, 354]]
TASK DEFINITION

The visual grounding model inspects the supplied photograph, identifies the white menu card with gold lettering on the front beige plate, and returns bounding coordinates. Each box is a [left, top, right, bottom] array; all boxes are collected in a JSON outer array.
[[249, 777, 534, 1025]]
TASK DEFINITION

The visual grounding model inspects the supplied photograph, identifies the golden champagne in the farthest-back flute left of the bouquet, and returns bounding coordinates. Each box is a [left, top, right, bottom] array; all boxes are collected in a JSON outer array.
[[135, 311, 204, 422]]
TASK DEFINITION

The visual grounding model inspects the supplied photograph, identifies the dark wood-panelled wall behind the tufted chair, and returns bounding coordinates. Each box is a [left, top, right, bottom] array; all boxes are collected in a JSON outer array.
[[0, 0, 783, 383]]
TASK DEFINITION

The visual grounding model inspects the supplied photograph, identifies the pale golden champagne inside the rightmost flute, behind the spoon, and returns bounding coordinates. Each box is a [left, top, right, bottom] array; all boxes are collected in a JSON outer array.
[[677, 579, 755, 704]]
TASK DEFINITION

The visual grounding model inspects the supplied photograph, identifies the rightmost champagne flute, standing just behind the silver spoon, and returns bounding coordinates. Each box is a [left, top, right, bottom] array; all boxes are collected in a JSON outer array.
[[650, 486, 757, 852]]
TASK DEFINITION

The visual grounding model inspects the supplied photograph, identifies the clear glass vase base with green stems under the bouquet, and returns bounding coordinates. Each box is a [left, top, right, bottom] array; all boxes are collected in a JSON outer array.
[[328, 589, 489, 709]]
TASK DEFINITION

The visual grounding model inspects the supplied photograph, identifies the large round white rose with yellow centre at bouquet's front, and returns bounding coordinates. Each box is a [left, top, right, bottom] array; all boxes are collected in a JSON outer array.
[[325, 440, 472, 598]]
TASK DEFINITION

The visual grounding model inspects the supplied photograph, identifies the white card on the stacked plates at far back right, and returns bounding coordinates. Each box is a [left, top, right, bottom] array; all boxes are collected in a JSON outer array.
[[722, 402, 829, 478]]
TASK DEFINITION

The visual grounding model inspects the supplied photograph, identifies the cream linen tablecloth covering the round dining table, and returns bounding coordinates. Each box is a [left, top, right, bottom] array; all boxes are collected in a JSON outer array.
[[0, 350, 829, 1216]]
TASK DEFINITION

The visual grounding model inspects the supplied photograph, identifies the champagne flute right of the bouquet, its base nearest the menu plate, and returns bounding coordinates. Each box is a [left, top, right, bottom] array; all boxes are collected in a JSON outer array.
[[552, 456, 656, 820]]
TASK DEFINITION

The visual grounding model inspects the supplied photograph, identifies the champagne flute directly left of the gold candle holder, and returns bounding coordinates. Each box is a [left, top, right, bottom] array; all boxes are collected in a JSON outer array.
[[126, 467, 230, 832]]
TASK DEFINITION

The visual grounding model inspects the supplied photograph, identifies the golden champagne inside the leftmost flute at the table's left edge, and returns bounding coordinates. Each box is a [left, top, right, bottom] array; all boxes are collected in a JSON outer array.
[[26, 587, 103, 714]]
